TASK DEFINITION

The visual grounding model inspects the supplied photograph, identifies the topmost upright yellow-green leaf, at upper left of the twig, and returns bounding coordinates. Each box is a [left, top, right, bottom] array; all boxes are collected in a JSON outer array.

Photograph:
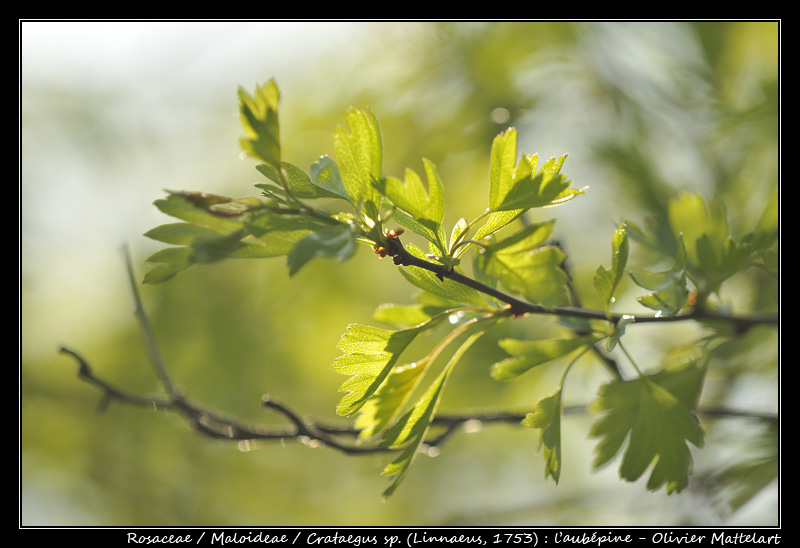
[[238, 80, 281, 169]]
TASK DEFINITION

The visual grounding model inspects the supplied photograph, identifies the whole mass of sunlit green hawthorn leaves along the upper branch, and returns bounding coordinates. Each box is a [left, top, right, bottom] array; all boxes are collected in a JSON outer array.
[[145, 81, 778, 496]]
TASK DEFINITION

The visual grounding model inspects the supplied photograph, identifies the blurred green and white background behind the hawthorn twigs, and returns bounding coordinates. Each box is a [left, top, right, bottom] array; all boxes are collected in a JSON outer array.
[[20, 22, 780, 526]]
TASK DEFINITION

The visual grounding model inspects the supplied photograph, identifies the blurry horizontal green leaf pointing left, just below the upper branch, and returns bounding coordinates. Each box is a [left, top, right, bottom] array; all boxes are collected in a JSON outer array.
[[490, 335, 599, 381]]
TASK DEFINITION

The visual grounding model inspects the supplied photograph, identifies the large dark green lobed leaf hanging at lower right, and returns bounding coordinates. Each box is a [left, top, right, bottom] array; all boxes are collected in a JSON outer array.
[[591, 370, 704, 493]]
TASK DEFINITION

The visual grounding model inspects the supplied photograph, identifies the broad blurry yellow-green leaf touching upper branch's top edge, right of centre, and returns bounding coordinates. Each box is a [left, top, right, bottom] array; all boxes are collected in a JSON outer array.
[[475, 221, 568, 307]]
